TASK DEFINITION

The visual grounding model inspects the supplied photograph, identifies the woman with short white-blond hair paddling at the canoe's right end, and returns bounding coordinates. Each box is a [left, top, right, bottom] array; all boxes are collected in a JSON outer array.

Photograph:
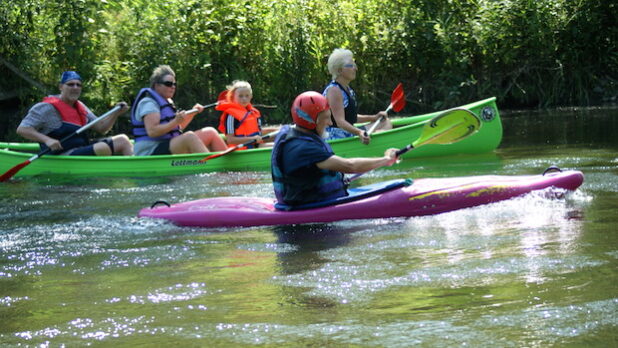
[[322, 48, 393, 144]]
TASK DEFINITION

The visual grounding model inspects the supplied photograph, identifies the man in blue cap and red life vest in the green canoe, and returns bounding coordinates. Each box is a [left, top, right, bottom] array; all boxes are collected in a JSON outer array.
[[17, 71, 133, 156]]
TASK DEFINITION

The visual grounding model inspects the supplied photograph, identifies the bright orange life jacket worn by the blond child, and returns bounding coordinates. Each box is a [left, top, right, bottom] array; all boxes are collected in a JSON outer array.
[[215, 102, 262, 147]]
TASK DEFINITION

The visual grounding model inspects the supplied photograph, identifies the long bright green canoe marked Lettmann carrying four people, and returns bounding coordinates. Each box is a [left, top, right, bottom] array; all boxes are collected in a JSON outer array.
[[0, 97, 502, 177]]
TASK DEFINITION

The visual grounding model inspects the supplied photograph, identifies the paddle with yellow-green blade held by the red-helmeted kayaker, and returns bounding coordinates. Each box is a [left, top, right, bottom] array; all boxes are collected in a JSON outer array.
[[346, 108, 481, 183]]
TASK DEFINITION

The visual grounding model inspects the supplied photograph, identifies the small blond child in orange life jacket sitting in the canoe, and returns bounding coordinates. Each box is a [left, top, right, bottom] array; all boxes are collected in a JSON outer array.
[[216, 80, 278, 148]]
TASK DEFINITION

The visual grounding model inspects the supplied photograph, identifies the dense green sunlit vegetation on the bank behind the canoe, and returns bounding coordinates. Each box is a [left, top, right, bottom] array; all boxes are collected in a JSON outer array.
[[0, 0, 618, 139]]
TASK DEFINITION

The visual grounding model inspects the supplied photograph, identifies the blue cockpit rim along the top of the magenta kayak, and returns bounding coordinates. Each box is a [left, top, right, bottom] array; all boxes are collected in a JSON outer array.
[[275, 179, 412, 211]]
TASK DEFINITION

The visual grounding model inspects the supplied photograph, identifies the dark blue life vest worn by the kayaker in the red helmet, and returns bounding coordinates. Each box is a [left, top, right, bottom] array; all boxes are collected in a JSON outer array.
[[271, 126, 348, 205]]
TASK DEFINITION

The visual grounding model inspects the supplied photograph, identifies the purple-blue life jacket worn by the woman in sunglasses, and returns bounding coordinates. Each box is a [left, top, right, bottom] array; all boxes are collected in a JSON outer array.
[[131, 88, 181, 141]]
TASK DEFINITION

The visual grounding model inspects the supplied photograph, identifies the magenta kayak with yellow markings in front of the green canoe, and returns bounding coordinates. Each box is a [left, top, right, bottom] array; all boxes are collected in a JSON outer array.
[[138, 171, 584, 227]]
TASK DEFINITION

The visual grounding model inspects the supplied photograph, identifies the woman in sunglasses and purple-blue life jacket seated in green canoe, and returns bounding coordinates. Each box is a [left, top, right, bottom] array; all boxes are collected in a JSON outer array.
[[131, 65, 227, 156]]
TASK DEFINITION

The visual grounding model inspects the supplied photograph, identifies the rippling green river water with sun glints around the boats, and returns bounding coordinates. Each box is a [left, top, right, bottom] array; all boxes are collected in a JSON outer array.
[[0, 108, 618, 347]]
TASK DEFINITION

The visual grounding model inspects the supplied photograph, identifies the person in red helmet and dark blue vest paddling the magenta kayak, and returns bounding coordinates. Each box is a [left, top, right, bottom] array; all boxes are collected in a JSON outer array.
[[271, 92, 397, 206]]
